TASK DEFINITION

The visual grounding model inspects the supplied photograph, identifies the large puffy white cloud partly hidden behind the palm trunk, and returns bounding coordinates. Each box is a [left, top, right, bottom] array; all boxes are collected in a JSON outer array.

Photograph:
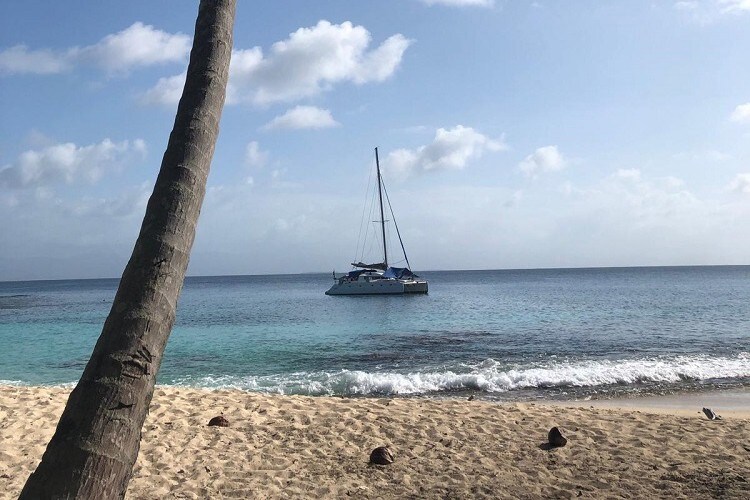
[[146, 21, 412, 105]]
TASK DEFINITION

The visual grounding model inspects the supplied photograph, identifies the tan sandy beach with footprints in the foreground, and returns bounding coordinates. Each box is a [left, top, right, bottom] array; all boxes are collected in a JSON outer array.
[[0, 387, 750, 499]]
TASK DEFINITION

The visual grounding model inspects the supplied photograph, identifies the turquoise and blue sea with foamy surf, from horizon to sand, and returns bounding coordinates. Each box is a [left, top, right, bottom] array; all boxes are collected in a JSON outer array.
[[0, 266, 750, 400]]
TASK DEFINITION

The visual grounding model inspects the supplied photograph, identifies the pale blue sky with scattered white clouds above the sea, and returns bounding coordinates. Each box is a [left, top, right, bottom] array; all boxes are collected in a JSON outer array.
[[0, 0, 750, 281]]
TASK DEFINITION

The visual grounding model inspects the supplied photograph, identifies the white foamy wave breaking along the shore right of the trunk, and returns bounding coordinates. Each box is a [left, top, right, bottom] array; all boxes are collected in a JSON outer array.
[[174, 353, 750, 395]]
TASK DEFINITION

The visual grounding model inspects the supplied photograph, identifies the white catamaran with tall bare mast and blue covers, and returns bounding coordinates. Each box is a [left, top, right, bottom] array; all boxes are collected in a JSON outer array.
[[326, 148, 427, 295]]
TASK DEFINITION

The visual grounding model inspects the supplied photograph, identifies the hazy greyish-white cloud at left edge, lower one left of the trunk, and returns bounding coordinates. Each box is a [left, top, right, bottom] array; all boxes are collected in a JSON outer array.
[[0, 139, 146, 189]]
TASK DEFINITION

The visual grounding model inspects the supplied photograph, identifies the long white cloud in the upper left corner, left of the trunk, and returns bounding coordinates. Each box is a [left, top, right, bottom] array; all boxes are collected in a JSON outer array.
[[0, 22, 191, 74]]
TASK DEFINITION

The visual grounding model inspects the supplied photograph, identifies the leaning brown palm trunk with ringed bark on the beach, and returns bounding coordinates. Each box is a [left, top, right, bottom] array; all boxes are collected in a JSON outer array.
[[21, 0, 235, 499]]
